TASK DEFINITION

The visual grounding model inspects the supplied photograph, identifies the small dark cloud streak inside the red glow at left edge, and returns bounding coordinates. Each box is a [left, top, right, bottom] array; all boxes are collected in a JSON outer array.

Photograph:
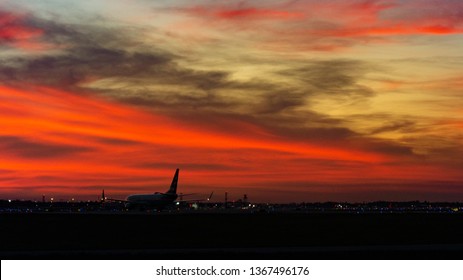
[[0, 136, 91, 159]]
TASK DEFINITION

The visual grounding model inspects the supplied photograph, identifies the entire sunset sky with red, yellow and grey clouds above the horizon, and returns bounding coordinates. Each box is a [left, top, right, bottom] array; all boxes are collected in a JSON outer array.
[[0, 0, 463, 202]]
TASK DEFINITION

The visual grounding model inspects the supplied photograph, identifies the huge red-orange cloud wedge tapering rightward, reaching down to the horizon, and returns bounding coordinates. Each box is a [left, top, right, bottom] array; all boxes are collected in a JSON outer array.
[[0, 83, 463, 200]]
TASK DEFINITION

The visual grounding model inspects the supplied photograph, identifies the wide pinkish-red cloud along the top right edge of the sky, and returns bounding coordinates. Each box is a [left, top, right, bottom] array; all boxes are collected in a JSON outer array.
[[169, 0, 463, 51]]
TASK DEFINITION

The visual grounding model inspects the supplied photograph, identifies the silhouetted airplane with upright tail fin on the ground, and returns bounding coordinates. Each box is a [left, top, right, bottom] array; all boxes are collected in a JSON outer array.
[[102, 168, 212, 210]]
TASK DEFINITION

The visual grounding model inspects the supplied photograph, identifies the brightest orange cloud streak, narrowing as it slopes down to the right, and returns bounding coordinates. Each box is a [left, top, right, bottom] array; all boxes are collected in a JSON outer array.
[[0, 84, 392, 162]]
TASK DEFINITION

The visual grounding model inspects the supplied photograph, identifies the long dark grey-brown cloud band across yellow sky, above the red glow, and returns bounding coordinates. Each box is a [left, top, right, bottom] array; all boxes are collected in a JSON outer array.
[[0, 10, 371, 109]]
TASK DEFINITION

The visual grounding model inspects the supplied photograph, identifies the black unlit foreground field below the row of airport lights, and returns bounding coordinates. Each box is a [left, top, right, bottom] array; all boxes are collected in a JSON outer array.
[[0, 213, 463, 259]]
